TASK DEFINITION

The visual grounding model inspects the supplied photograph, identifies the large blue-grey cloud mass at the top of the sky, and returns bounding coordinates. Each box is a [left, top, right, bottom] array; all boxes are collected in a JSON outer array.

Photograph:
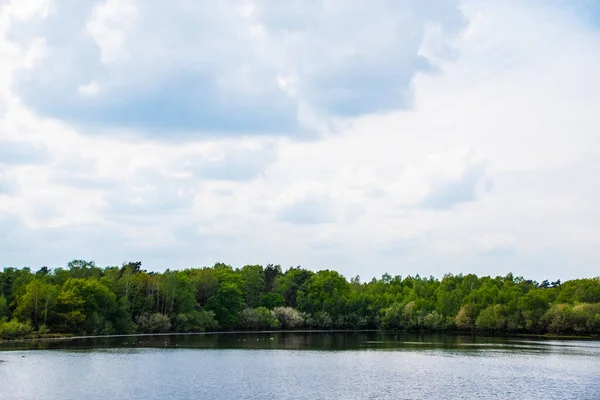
[[9, 0, 465, 140]]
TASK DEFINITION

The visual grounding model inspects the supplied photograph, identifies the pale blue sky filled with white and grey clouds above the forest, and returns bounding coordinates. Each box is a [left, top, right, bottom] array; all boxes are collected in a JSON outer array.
[[0, 0, 600, 281]]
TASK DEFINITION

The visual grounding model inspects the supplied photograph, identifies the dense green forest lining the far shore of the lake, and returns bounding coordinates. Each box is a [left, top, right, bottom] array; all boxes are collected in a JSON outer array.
[[0, 260, 600, 339]]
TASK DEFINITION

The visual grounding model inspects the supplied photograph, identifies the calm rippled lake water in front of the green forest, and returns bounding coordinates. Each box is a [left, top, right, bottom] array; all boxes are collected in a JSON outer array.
[[0, 332, 600, 400]]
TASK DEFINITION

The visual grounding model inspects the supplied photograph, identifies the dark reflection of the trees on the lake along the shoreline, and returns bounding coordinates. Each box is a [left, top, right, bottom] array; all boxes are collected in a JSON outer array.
[[0, 331, 600, 358]]
